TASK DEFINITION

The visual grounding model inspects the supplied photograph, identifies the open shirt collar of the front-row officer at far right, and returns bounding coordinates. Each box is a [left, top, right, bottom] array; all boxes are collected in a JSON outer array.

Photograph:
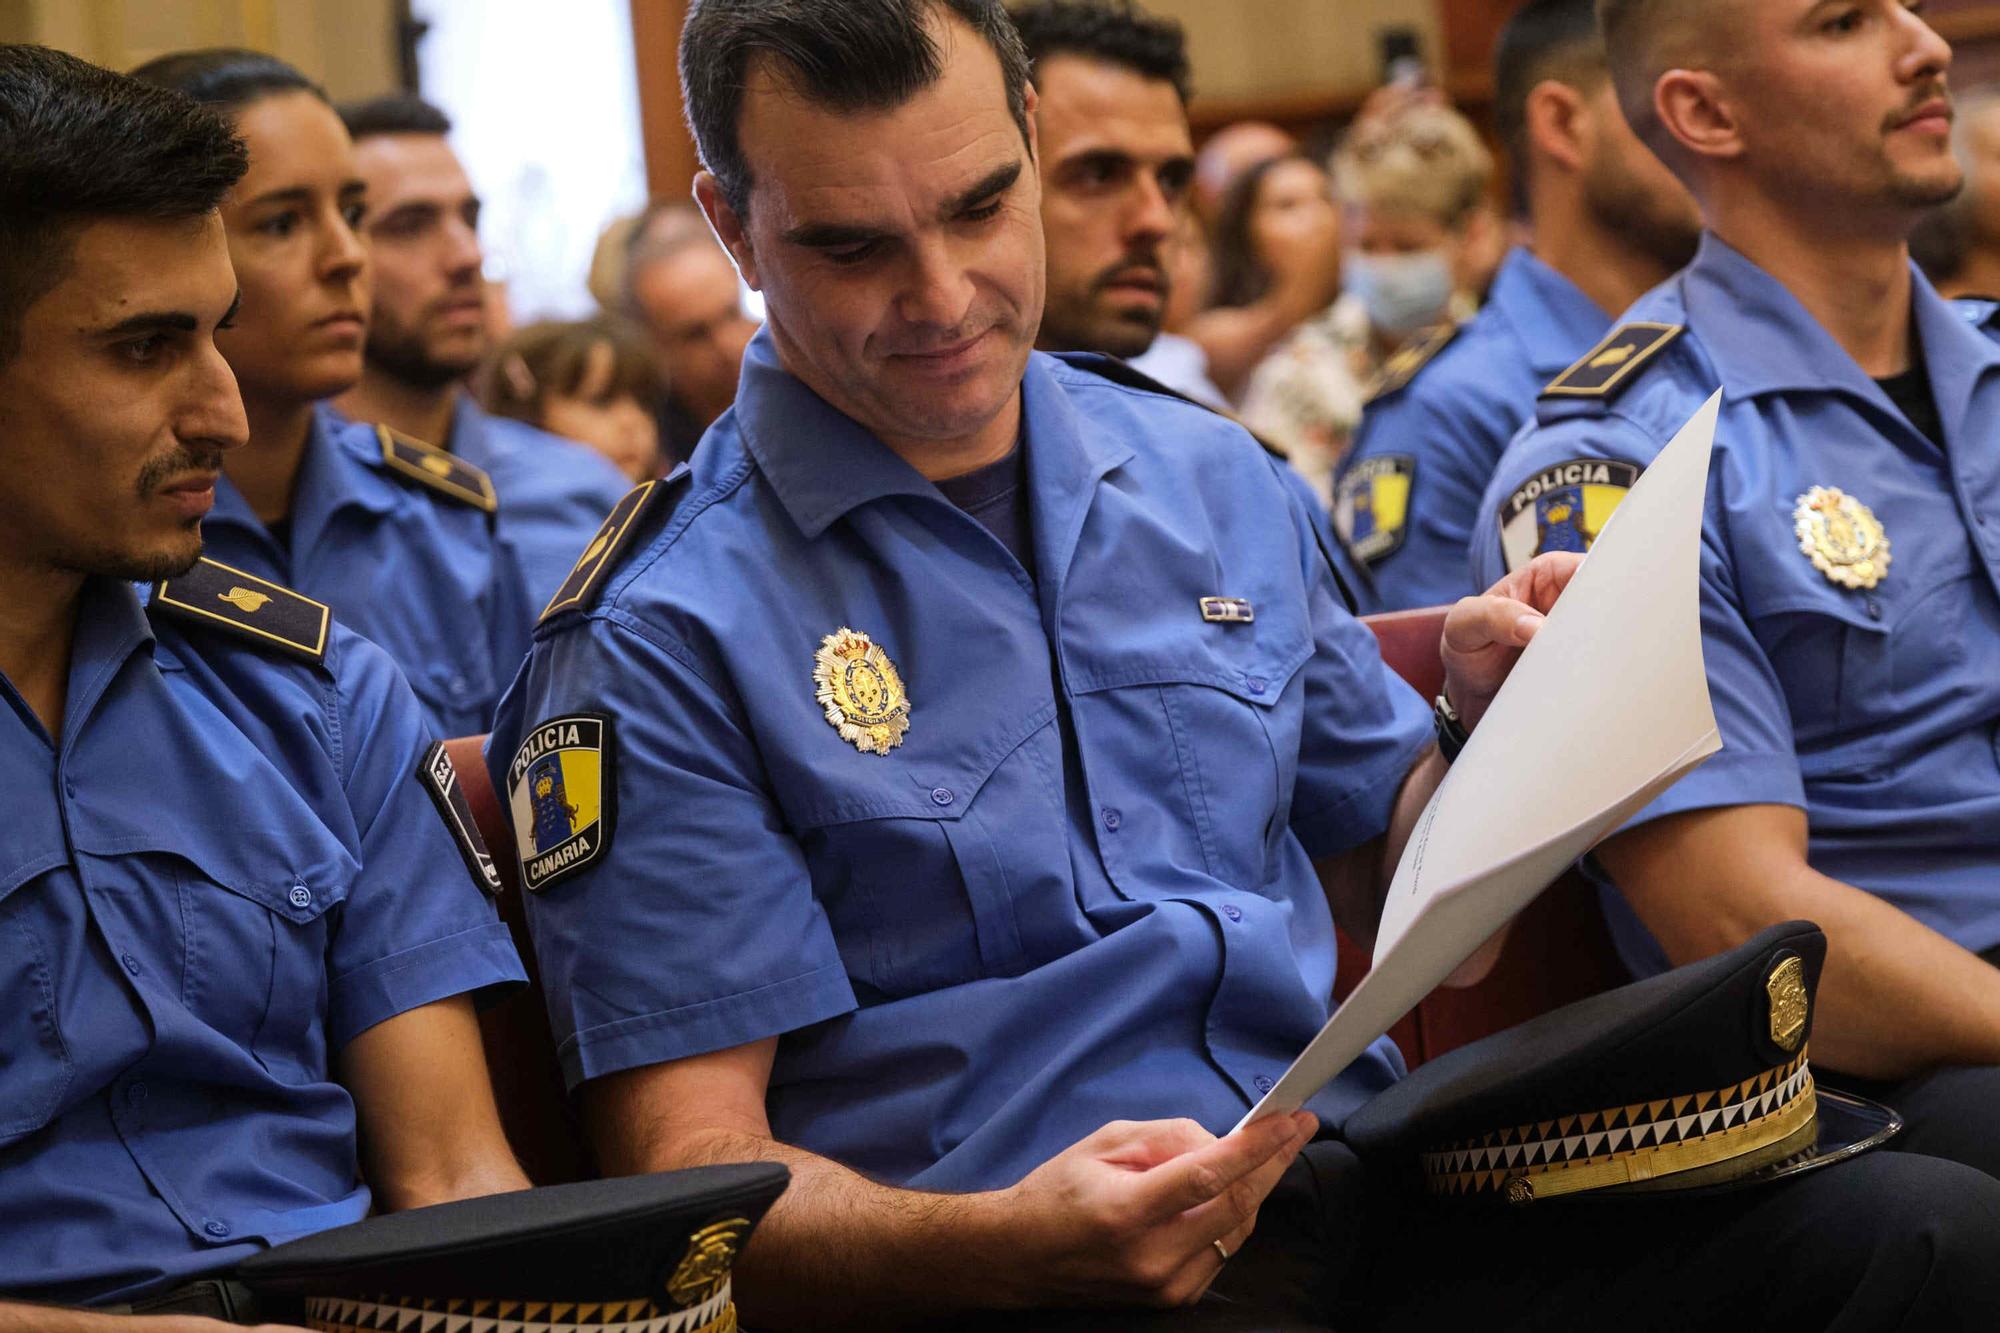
[[1680, 232, 2000, 422]]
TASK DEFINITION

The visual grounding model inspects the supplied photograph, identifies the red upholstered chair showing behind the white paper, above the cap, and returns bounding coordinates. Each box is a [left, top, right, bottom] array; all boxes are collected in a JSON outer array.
[[1336, 606, 1630, 1067]]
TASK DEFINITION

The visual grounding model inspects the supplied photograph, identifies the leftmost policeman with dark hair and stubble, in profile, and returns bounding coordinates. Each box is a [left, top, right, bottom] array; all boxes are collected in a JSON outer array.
[[0, 46, 526, 1333]]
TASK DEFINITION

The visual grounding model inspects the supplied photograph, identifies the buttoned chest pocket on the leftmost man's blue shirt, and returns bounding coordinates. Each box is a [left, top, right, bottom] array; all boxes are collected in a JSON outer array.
[[75, 811, 360, 1083]]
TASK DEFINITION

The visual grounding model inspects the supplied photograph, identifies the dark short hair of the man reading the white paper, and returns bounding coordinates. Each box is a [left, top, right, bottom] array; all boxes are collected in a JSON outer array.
[[680, 0, 1028, 216]]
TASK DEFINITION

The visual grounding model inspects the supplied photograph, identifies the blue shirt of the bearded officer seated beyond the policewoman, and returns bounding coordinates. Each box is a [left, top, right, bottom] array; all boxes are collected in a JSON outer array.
[[446, 394, 632, 610]]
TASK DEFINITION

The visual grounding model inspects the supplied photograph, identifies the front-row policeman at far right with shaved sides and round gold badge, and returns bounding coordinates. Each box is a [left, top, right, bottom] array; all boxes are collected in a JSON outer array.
[[1476, 0, 2000, 1171]]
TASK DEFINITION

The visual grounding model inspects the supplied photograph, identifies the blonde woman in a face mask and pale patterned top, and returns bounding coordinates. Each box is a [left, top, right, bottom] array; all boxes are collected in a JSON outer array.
[[1242, 106, 1500, 500]]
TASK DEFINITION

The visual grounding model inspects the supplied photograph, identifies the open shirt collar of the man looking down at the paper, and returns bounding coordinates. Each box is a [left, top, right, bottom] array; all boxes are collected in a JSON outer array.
[[732, 328, 1132, 570]]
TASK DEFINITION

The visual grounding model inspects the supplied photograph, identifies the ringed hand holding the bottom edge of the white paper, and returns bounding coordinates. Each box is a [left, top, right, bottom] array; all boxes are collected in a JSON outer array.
[[998, 1111, 1318, 1307]]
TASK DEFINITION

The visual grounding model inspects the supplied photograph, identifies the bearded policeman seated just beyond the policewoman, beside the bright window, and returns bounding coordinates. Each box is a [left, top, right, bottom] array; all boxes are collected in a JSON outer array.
[[338, 96, 630, 610]]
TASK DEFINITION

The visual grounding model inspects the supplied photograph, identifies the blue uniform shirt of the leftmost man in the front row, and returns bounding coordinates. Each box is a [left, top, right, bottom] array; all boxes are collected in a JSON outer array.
[[0, 580, 522, 1303]]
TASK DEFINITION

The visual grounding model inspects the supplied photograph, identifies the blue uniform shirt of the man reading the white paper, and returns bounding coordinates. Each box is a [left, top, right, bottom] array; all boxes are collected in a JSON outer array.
[[488, 334, 1430, 1191]]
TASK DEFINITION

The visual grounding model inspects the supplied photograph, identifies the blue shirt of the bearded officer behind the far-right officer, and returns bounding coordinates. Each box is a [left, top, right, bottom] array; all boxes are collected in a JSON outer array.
[[1334, 250, 1610, 612]]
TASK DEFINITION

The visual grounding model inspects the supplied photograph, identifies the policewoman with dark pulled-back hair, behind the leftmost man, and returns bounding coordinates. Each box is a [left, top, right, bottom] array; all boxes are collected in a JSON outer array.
[[136, 50, 534, 737]]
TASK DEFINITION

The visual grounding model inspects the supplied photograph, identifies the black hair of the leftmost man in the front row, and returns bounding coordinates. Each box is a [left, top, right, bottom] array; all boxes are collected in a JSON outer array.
[[0, 46, 248, 362]]
